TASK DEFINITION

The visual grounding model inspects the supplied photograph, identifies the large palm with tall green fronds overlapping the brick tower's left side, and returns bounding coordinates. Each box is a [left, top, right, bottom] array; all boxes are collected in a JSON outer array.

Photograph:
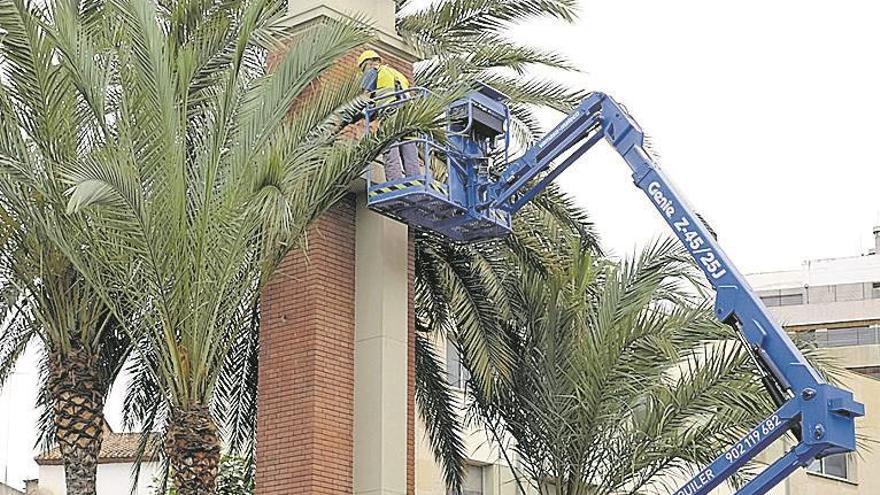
[[59, 0, 443, 495]]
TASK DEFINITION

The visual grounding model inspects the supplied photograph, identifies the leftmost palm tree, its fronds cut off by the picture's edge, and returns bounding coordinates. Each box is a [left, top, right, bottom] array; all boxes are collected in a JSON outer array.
[[0, 0, 130, 494]]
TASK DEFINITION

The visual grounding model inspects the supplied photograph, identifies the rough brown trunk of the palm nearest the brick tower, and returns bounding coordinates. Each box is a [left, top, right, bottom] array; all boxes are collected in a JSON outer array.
[[165, 405, 220, 495]]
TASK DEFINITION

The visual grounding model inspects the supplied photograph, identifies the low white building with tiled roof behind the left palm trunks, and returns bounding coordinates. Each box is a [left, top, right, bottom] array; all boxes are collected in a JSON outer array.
[[26, 428, 160, 495]]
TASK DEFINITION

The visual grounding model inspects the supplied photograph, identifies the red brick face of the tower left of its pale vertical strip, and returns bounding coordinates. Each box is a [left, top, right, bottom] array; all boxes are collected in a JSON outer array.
[[256, 195, 355, 495]]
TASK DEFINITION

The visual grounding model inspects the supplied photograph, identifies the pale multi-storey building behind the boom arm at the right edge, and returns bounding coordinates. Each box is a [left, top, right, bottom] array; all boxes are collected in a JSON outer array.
[[747, 227, 880, 495]]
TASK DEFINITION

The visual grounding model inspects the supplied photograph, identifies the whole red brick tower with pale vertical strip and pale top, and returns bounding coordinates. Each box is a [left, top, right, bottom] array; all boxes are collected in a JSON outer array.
[[256, 0, 415, 495]]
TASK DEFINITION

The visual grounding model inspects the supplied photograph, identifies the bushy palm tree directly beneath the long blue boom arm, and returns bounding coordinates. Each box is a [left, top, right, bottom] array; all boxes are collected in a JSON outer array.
[[460, 240, 772, 495]]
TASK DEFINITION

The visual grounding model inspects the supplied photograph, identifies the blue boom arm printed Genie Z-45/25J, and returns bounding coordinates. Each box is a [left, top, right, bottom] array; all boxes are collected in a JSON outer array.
[[488, 93, 864, 495]]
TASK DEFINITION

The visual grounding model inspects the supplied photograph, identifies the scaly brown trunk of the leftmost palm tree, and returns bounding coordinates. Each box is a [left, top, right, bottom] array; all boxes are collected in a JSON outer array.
[[49, 346, 106, 495]]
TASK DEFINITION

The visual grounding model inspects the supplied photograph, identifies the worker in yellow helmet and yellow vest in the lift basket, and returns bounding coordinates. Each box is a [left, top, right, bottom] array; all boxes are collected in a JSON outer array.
[[358, 50, 420, 181]]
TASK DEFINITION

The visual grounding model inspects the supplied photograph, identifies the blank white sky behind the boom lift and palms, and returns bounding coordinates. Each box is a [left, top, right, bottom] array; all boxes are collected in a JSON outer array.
[[0, 0, 880, 486]]
